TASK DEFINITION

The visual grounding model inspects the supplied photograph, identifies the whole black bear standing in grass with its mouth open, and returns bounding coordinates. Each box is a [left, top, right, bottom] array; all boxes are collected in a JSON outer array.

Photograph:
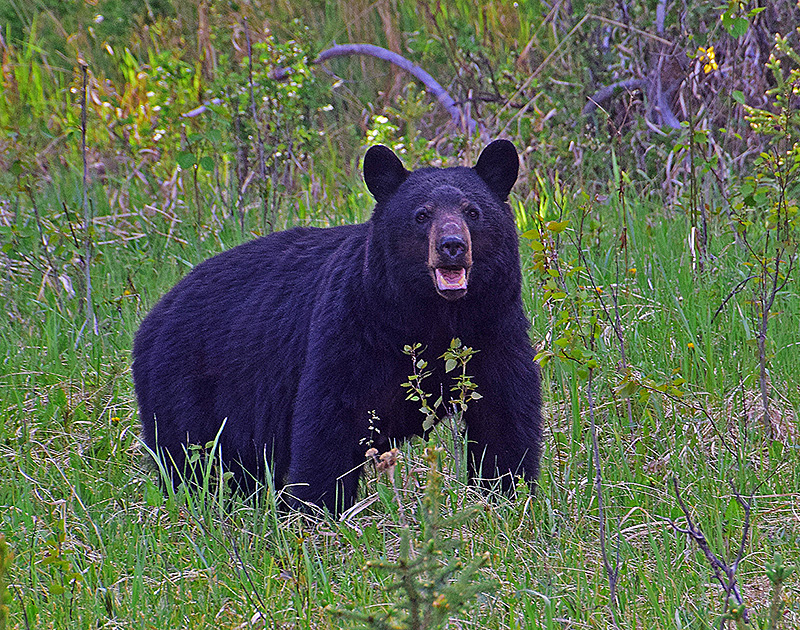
[[133, 140, 542, 512]]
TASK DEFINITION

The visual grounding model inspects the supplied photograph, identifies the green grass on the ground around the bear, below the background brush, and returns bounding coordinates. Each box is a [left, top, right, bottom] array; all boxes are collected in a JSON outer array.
[[0, 164, 800, 629]]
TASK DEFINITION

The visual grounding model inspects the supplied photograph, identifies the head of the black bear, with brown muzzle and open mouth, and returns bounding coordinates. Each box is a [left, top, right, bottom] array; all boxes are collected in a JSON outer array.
[[364, 140, 519, 302]]
